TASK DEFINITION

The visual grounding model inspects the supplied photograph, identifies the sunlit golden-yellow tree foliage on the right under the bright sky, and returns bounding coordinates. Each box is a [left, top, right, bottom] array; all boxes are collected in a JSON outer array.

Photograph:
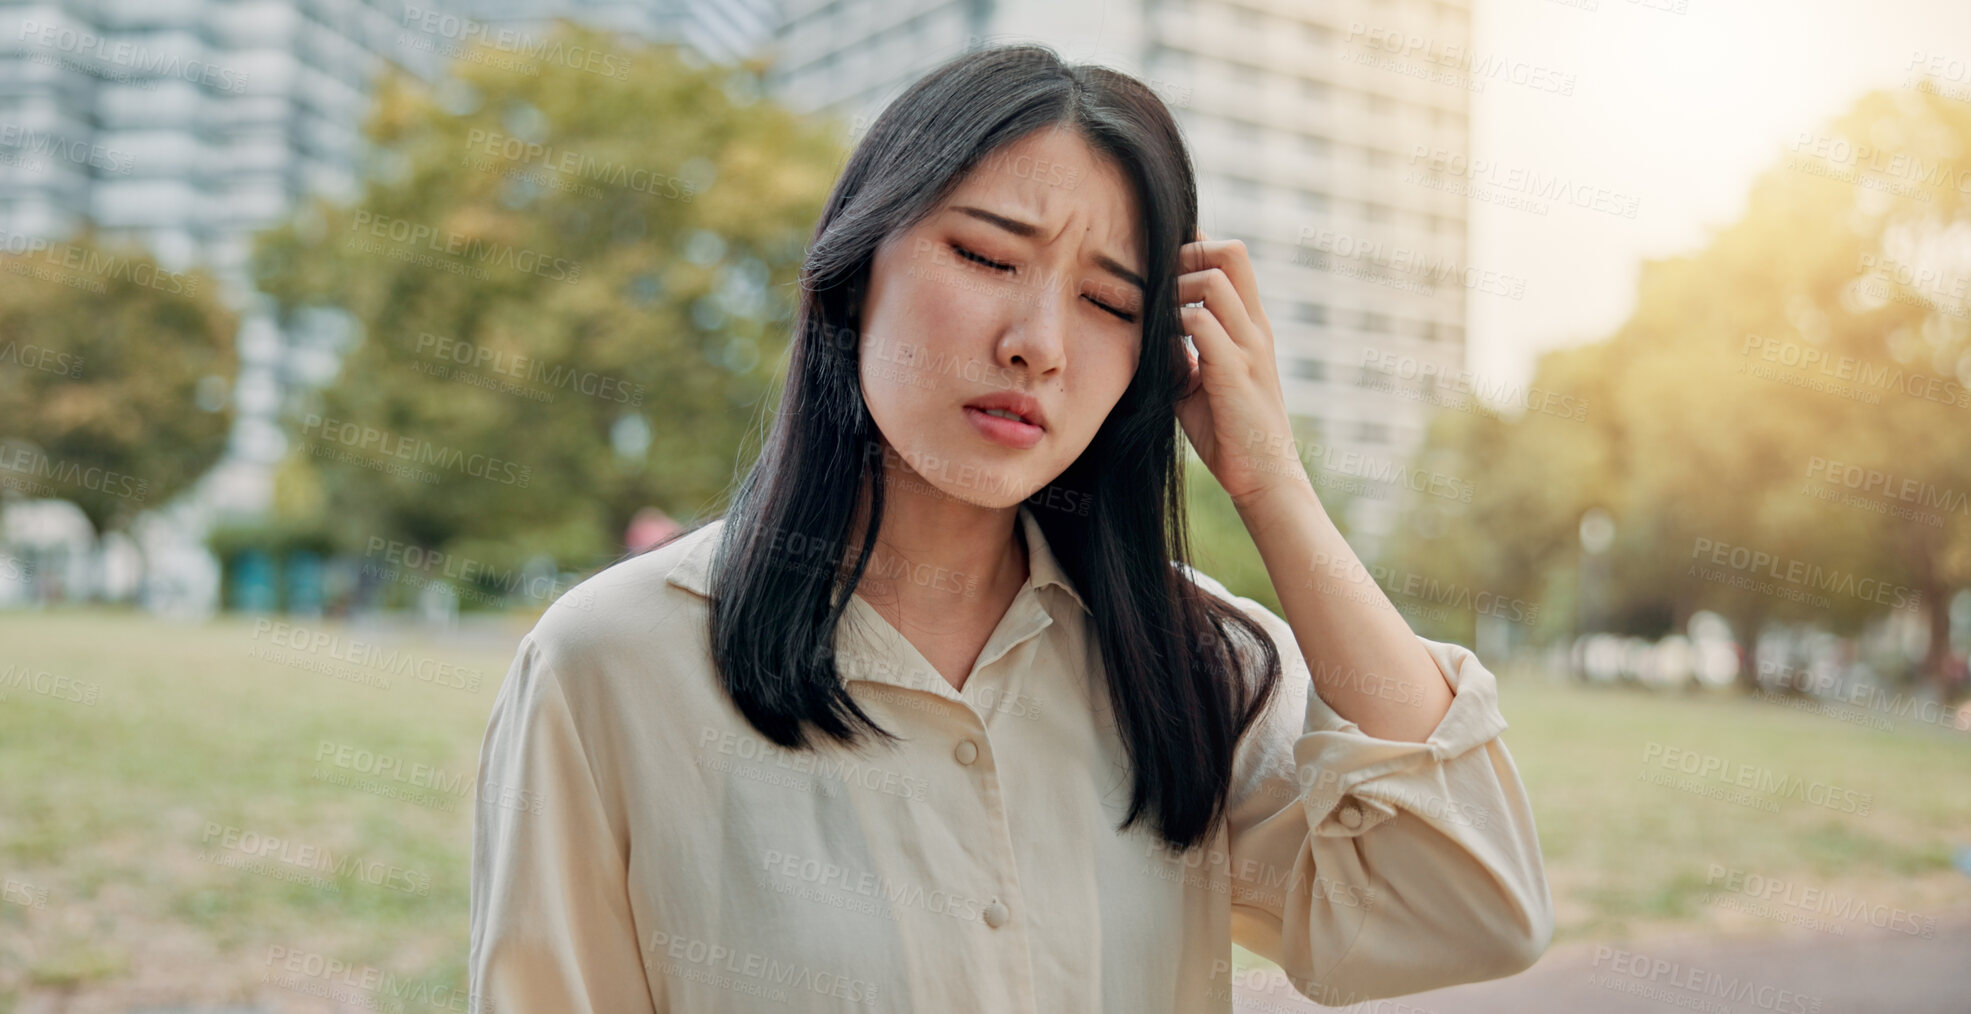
[[1379, 91, 1971, 679]]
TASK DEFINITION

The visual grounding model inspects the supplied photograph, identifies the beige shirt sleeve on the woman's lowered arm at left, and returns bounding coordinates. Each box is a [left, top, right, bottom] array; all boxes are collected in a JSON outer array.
[[467, 635, 654, 1014]]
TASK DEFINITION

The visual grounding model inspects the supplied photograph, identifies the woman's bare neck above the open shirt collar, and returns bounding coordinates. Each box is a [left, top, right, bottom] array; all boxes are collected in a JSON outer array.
[[842, 445, 1027, 611]]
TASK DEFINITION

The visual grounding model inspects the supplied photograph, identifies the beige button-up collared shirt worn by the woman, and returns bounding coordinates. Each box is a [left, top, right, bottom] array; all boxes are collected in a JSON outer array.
[[467, 505, 1553, 1014]]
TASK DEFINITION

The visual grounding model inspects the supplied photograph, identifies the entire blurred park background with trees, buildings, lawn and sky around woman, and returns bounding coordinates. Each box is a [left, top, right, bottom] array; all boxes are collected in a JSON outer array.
[[0, 0, 1971, 1014]]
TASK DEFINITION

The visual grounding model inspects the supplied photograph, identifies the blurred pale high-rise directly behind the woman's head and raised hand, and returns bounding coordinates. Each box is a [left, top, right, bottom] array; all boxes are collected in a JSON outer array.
[[769, 0, 1484, 556]]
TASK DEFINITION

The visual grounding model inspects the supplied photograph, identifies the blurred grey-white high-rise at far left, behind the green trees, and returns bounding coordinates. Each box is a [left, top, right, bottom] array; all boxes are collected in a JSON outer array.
[[0, 0, 775, 556]]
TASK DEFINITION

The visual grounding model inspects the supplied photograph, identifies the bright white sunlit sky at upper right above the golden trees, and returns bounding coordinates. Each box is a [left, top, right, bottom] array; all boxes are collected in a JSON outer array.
[[1466, 0, 1971, 398]]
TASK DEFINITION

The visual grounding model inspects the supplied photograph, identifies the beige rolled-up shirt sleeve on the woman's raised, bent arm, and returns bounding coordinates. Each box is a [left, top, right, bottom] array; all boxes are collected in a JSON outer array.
[[1218, 586, 1553, 1006]]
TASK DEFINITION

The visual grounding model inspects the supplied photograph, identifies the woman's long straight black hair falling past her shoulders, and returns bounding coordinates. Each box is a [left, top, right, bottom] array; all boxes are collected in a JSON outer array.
[[693, 43, 1281, 848]]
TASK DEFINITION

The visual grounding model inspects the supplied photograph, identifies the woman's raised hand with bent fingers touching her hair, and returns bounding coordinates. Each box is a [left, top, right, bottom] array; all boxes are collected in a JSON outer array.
[[1177, 229, 1313, 509]]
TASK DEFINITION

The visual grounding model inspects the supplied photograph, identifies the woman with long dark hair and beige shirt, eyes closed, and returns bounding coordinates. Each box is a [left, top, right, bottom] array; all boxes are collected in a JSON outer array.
[[469, 45, 1553, 1014]]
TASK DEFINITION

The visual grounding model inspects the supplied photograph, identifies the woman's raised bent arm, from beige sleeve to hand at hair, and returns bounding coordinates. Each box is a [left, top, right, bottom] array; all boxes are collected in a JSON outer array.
[[1177, 233, 1553, 1006]]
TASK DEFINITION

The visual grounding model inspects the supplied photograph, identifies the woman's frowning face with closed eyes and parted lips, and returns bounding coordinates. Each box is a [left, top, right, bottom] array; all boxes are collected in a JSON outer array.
[[859, 128, 1143, 507]]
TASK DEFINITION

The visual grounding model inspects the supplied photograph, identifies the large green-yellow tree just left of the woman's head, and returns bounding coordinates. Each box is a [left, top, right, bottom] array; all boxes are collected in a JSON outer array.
[[256, 26, 842, 566]]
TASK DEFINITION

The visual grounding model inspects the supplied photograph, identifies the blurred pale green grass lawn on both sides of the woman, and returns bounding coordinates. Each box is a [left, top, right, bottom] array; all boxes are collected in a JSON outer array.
[[0, 612, 1971, 1014]]
